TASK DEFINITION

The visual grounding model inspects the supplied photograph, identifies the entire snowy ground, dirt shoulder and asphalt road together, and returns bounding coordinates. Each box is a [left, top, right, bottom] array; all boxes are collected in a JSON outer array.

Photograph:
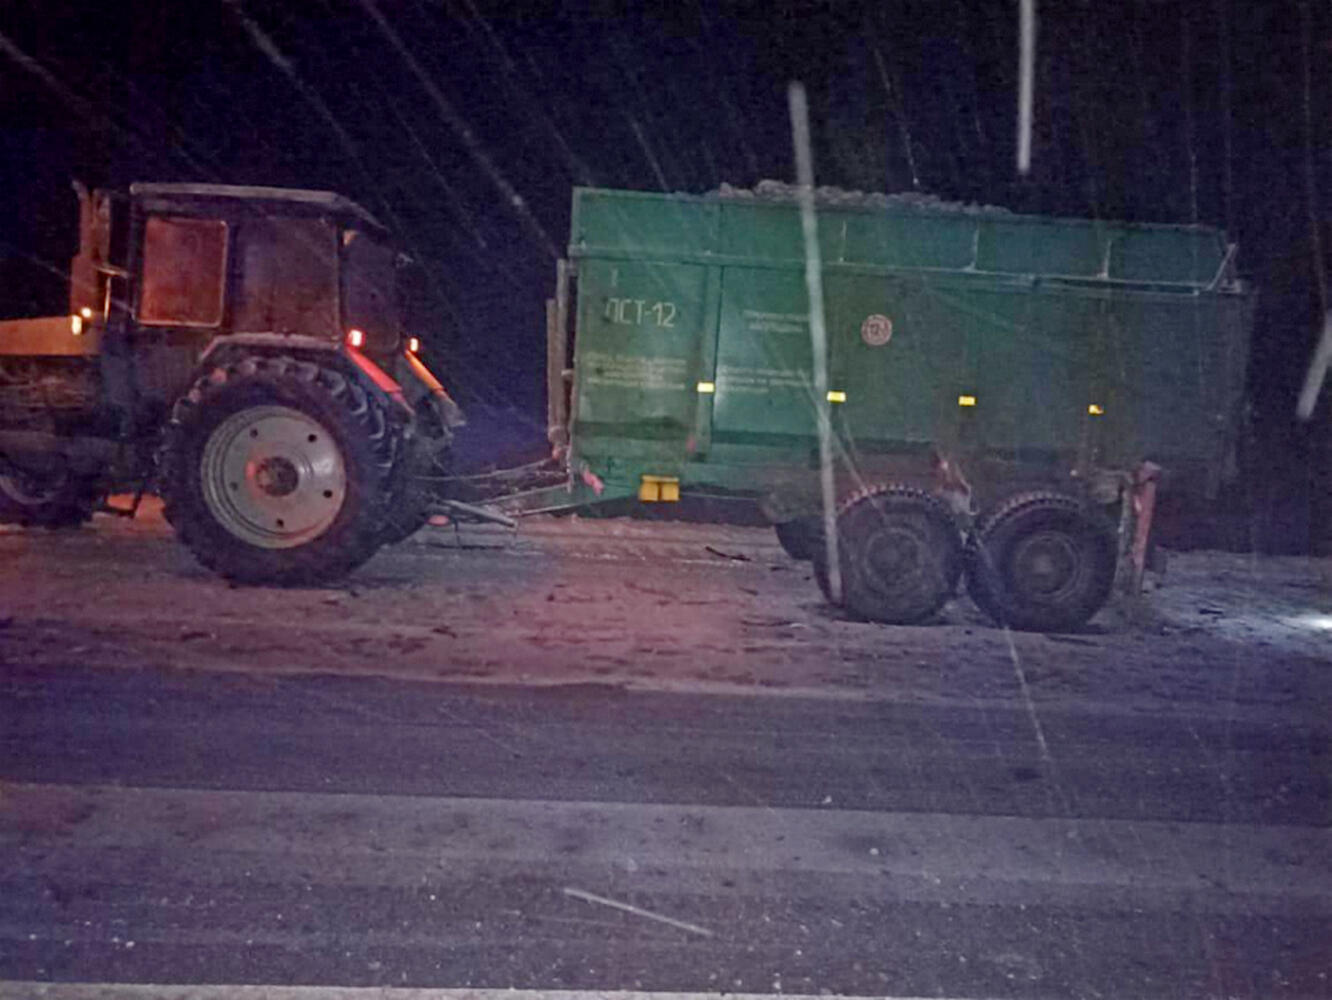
[[0, 510, 1332, 1000]]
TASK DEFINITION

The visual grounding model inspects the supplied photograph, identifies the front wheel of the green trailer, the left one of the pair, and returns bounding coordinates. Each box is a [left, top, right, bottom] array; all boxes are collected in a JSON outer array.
[[814, 486, 962, 625]]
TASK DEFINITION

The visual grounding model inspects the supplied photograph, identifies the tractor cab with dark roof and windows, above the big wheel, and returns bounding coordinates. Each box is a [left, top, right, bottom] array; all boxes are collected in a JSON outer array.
[[71, 184, 404, 415]]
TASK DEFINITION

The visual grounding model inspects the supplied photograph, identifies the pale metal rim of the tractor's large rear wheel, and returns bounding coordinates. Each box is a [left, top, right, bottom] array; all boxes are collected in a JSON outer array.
[[200, 406, 346, 549]]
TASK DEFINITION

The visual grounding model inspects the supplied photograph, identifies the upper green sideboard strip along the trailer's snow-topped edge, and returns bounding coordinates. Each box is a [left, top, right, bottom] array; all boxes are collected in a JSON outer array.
[[569, 181, 1247, 294]]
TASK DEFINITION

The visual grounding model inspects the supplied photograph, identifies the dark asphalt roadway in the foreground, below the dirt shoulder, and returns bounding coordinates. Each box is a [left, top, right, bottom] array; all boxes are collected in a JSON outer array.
[[0, 663, 1332, 997]]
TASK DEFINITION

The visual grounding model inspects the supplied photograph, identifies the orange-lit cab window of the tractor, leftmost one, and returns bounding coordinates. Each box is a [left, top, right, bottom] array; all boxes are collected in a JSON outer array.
[[139, 216, 226, 326]]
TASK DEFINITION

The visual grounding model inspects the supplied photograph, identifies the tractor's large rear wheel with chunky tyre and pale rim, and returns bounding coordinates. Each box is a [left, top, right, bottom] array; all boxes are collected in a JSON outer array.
[[161, 357, 398, 586]]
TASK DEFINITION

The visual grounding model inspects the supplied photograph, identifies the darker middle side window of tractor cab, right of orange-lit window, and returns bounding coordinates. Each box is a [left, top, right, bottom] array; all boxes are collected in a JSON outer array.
[[232, 217, 341, 338]]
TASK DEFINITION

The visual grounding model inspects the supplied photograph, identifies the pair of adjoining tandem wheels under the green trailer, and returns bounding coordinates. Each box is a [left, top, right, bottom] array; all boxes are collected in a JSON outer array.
[[779, 486, 1116, 631]]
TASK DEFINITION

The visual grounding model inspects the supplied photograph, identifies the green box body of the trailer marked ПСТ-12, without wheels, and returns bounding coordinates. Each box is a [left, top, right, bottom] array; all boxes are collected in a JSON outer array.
[[556, 189, 1252, 508]]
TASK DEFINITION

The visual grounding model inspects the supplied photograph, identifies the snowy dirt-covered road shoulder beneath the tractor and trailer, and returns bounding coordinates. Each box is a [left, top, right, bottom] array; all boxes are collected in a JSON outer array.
[[0, 503, 1332, 720]]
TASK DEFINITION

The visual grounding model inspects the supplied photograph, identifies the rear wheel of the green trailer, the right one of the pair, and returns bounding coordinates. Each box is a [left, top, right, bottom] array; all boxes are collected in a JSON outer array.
[[967, 493, 1116, 632]]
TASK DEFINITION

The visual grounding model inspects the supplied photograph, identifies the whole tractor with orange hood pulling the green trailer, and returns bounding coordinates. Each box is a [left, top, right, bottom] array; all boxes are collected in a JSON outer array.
[[0, 184, 464, 585]]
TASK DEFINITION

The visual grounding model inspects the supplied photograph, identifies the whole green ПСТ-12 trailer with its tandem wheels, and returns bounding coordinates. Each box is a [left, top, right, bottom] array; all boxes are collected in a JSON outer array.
[[500, 189, 1252, 628]]
